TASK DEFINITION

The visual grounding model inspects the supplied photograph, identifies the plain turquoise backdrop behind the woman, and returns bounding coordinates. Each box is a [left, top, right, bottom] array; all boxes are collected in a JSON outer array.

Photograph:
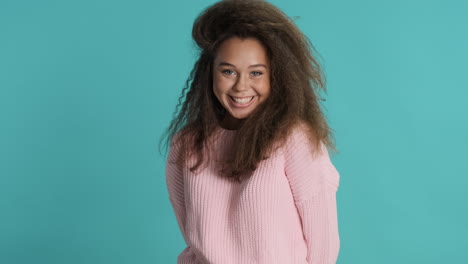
[[0, 0, 468, 264]]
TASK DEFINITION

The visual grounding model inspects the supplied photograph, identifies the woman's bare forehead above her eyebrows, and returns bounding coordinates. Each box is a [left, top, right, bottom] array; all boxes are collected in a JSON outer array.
[[215, 37, 268, 66]]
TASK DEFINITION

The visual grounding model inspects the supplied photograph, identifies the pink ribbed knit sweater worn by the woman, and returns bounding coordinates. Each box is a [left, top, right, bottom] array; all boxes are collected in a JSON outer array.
[[166, 124, 340, 264]]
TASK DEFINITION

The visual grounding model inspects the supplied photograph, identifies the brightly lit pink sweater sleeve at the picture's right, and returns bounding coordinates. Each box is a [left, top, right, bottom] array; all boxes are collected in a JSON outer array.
[[285, 126, 340, 264]]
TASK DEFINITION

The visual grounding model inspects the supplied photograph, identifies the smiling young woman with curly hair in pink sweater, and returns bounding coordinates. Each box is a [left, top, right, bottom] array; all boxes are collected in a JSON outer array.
[[165, 0, 340, 264]]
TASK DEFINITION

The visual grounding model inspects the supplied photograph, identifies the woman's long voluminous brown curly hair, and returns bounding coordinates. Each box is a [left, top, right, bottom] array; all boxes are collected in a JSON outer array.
[[160, 0, 337, 181]]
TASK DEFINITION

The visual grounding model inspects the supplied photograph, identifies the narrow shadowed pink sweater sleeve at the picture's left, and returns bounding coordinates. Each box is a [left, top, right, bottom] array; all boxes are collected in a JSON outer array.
[[166, 133, 187, 246]]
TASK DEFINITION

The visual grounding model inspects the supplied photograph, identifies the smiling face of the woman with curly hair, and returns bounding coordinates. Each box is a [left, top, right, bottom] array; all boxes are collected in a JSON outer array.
[[213, 37, 270, 129]]
